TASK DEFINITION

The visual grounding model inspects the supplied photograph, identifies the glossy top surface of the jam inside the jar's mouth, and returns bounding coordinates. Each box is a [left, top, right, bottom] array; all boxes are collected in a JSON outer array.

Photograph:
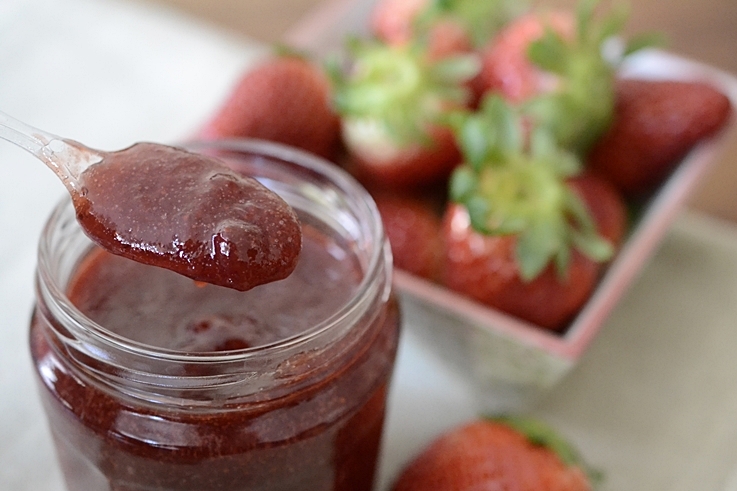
[[68, 227, 361, 353]]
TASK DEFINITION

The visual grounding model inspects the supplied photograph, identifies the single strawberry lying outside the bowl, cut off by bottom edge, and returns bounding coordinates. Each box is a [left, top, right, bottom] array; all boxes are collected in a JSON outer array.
[[392, 418, 600, 491]]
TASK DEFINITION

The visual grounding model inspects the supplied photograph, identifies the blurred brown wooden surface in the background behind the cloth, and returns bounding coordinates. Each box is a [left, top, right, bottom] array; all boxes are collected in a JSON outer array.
[[142, 0, 737, 221]]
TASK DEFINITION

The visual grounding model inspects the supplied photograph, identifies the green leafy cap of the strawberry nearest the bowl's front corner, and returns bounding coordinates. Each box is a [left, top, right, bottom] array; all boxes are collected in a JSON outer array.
[[450, 96, 613, 281]]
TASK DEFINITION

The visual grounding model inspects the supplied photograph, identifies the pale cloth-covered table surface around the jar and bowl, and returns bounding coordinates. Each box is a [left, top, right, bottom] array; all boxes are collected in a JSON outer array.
[[0, 0, 737, 491]]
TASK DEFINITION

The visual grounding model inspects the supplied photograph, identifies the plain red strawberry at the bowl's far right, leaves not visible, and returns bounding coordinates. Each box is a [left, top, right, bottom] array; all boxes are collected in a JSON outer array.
[[588, 80, 732, 196]]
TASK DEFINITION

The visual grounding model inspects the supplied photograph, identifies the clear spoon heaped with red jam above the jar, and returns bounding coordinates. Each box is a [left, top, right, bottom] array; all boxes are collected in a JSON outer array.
[[0, 112, 302, 290]]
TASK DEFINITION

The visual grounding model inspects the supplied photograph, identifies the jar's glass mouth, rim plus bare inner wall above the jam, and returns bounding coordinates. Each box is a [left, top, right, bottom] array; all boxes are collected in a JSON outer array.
[[37, 139, 391, 364]]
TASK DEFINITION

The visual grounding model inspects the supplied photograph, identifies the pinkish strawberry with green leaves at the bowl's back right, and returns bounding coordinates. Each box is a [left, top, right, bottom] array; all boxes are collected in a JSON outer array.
[[480, 0, 651, 153]]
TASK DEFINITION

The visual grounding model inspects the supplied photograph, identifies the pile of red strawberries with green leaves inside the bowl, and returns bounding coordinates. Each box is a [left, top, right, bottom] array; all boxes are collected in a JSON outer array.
[[201, 0, 731, 331]]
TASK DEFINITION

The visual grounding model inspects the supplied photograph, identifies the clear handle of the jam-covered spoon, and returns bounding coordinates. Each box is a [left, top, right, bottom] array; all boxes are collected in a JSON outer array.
[[0, 111, 103, 191]]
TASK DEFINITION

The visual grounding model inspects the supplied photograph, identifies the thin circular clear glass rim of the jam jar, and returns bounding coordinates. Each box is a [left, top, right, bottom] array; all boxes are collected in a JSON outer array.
[[37, 139, 392, 363]]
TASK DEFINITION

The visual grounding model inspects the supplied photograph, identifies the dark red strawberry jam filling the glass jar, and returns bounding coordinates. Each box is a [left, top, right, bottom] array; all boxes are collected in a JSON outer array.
[[31, 231, 399, 491]]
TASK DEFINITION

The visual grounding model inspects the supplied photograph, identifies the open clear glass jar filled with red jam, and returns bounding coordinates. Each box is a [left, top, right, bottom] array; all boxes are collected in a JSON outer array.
[[30, 141, 399, 491]]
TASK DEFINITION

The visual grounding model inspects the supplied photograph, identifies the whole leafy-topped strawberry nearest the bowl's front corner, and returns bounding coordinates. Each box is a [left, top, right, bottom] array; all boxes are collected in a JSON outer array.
[[442, 97, 626, 330]]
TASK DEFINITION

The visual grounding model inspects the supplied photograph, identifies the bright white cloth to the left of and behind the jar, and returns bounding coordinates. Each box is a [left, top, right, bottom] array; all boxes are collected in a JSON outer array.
[[0, 0, 262, 491]]
